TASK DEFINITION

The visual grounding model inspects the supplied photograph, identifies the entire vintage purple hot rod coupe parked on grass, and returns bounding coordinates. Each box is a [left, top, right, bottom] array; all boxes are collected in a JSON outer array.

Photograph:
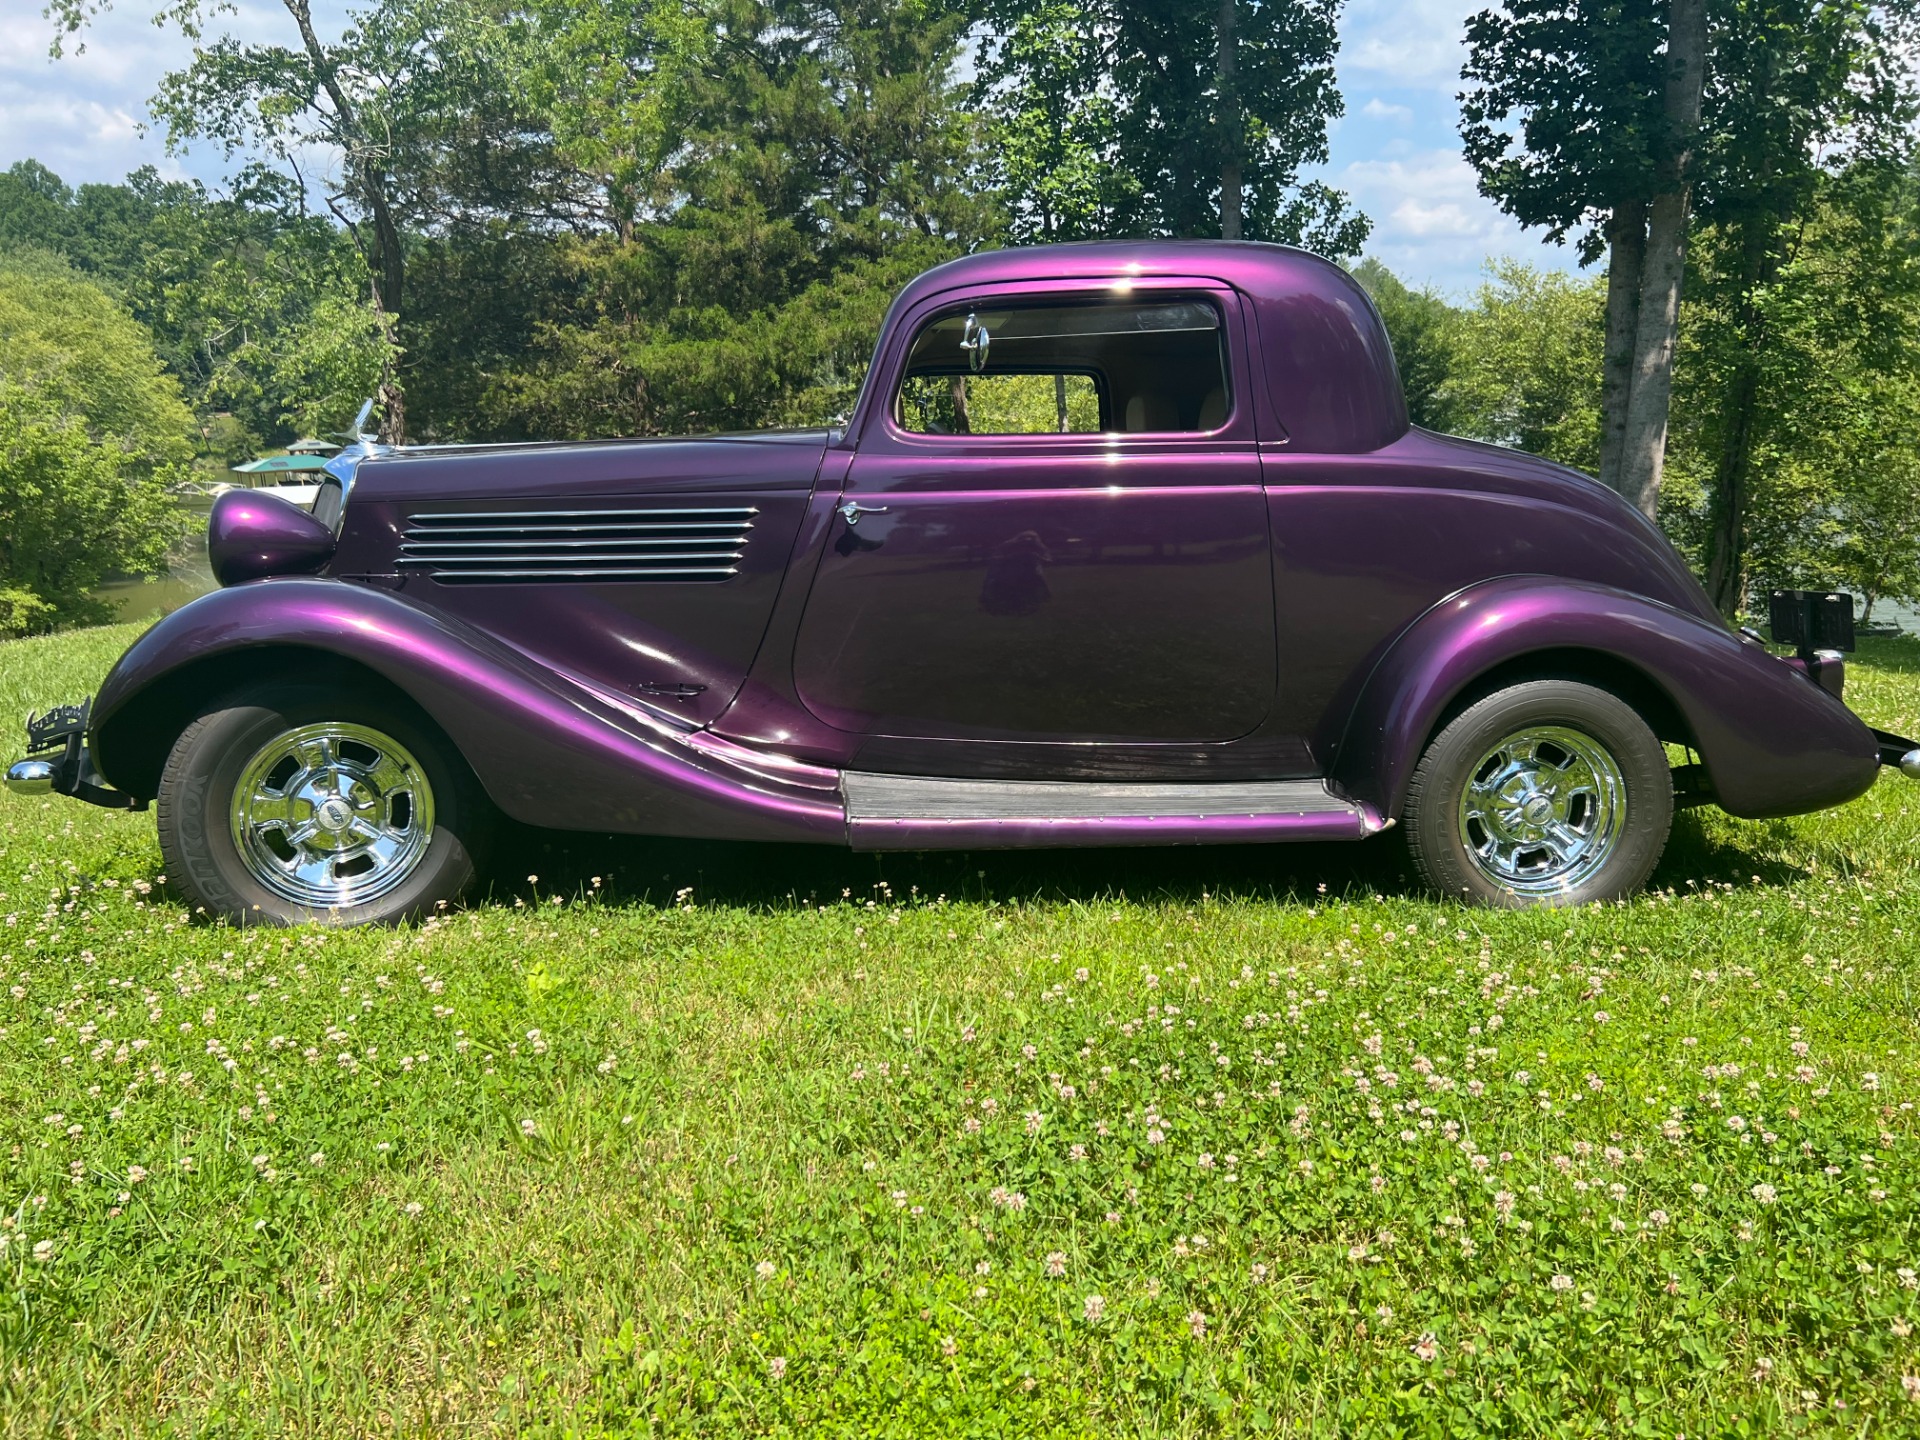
[[8, 242, 1920, 924]]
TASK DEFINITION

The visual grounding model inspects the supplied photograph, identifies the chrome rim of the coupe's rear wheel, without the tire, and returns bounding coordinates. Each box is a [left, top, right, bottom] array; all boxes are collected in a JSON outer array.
[[1459, 726, 1626, 895]]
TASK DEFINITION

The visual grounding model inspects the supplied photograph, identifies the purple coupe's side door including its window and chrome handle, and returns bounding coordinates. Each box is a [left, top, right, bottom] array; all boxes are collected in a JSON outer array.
[[793, 280, 1275, 756]]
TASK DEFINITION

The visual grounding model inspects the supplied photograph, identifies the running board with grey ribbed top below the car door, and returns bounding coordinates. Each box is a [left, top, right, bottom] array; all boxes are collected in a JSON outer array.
[[841, 770, 1390, 851]]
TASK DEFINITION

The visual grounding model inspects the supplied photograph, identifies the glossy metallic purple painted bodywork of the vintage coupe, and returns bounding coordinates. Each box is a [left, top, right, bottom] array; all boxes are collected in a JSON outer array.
[[52, 242, 1876, 867]]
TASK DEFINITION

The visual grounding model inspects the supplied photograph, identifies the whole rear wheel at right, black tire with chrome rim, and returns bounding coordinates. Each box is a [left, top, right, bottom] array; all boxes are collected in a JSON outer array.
[[1404, 680, 1674, 908]]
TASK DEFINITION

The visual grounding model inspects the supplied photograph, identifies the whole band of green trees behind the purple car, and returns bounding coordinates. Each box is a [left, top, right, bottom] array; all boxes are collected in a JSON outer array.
[[11, 0, 1920, 618]]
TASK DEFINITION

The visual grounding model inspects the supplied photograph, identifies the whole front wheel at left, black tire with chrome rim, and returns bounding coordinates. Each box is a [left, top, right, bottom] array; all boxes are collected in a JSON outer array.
[[156, 685, 493, 925]]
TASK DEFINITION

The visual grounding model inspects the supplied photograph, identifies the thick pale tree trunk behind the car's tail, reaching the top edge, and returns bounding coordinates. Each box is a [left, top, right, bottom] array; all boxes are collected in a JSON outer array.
[[1620, 0, 1707, 518]]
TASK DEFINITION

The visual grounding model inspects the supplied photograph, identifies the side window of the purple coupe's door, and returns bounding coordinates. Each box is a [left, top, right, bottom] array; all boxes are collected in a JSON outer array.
[[893, 300, 1231, 436]]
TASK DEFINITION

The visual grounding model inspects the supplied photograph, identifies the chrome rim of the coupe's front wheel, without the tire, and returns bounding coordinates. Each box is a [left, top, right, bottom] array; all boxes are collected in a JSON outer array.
[[232, 722, 434, 908]]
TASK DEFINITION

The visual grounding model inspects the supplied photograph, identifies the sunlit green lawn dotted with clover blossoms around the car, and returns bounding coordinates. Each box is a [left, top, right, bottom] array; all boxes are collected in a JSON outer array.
[[0, 628, 1920, 1436]]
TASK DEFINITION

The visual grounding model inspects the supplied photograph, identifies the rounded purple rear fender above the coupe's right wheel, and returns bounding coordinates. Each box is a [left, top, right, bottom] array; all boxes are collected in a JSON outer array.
[[1332, 576, 1878, 820]]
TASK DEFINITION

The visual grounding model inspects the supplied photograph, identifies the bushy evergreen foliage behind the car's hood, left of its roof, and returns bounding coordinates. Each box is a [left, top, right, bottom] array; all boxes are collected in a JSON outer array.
[[480, 0, 995, 436]]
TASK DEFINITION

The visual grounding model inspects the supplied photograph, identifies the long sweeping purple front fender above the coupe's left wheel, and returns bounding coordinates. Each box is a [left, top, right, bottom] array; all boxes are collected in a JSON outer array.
[[90, 578, 847, 841]]
